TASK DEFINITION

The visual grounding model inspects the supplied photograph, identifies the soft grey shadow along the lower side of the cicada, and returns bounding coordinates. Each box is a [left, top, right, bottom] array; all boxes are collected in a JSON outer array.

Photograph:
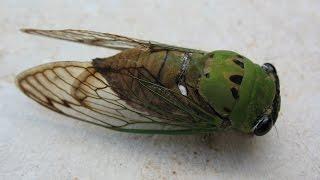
[[20, 94, 273, 173]]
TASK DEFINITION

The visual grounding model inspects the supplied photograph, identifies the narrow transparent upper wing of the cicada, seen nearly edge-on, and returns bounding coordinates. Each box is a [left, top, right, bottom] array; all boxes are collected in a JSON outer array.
[[22, 29, 205, 53]]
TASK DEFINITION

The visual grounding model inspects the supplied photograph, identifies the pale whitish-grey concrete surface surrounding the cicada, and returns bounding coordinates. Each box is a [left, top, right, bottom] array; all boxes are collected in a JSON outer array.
[[0, 0, 320, 179]]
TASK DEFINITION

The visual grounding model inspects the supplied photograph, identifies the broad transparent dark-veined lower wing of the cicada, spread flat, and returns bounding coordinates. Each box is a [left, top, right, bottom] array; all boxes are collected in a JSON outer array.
[[16, 61, 217, 134]]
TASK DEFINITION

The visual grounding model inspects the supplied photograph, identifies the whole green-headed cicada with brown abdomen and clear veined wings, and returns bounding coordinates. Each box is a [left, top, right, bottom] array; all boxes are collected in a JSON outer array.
[[16, 29, 280, 136]]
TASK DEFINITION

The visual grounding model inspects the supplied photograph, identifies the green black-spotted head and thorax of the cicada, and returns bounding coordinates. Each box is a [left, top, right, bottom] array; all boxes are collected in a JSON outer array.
[[199, 51, 280, 136]]
